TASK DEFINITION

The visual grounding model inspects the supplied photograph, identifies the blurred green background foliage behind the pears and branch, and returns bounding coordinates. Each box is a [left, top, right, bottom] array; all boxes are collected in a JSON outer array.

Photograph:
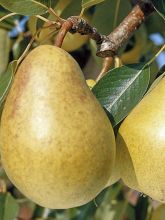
[[0, 0, 165, 220]]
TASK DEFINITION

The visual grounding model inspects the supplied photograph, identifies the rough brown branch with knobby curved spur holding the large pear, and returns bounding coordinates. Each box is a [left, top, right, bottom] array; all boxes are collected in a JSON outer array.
[[55, 0, 154, 58]]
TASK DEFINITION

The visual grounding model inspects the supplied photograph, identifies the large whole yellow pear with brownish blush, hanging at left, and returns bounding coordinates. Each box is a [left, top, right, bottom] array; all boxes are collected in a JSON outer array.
[[0, 45, 115, 209]]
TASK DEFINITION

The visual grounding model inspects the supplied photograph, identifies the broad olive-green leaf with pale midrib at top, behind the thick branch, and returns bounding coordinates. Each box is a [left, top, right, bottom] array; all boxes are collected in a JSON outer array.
[[92, 0, 131, 35]]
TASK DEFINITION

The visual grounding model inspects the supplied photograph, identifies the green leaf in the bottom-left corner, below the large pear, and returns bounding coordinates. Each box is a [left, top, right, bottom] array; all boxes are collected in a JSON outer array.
[[0, 193, 19, 220]]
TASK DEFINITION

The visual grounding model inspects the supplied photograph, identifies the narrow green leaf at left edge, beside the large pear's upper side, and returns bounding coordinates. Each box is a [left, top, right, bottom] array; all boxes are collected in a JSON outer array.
[[0, 61, 17, 106]]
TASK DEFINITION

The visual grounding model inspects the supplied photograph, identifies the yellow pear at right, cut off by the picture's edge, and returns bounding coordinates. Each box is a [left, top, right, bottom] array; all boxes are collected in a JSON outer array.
[[117, 78, 165, 202]]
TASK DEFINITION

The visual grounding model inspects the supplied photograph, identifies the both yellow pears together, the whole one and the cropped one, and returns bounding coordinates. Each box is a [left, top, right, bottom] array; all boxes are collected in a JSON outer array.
[[0, 45, 165, 209]]
